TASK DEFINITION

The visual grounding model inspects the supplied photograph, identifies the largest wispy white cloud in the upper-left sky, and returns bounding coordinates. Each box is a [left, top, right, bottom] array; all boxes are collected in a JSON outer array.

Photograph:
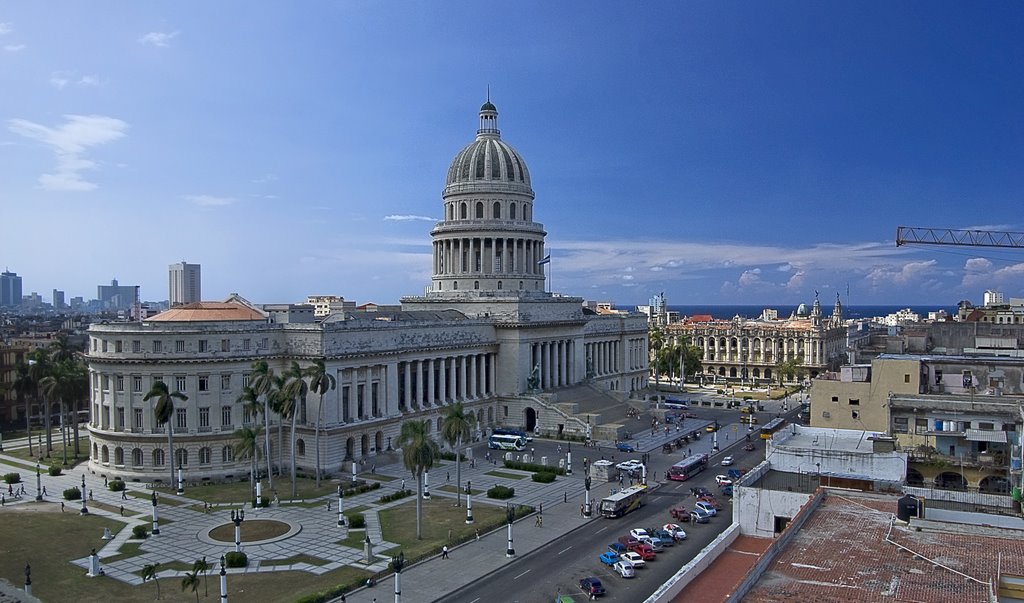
[[7, 115, 128, 190]]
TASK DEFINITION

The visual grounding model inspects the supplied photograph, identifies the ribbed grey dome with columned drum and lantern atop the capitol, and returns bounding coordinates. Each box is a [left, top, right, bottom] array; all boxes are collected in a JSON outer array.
[[427, 98, 546, 297]]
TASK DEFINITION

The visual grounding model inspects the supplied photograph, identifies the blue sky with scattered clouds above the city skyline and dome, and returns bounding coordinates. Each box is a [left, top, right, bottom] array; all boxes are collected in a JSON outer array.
[[0, 1, 1024, 305]]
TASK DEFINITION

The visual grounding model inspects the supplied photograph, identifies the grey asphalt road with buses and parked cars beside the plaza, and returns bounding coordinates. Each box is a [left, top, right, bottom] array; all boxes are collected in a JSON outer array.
[[441, 399, 770, 603]]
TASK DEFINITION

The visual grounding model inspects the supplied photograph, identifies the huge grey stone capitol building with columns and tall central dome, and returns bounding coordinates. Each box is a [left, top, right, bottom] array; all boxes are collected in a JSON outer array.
[[87, 100, 648, 481]]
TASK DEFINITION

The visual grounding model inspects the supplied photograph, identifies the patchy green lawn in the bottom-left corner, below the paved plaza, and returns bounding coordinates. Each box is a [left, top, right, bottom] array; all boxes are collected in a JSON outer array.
[[0, 505, 370, 603]]
